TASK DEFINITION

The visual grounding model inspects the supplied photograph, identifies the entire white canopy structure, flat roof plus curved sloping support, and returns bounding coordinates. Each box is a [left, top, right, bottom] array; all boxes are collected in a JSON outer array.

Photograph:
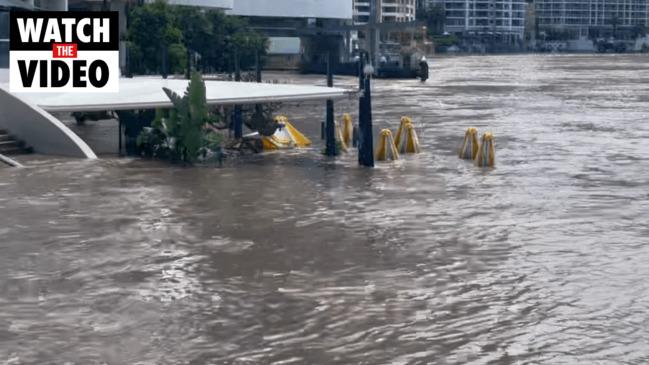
[[0, 77, 357, 158]]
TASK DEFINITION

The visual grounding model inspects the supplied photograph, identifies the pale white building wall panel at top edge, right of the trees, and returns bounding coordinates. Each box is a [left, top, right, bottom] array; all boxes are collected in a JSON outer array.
[[228, 0, 354, 19]]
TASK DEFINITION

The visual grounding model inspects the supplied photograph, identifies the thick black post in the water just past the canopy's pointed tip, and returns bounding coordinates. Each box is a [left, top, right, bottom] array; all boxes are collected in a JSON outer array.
[[358, 61, 374, 167]]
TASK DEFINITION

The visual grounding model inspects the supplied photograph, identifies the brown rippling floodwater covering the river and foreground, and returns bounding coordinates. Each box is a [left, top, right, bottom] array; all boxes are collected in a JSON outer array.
[[0, 55, 649, 365]]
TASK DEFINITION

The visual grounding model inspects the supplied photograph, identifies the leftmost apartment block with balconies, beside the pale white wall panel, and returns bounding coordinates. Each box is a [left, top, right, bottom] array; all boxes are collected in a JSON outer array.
[[354, 0, 417, 24]]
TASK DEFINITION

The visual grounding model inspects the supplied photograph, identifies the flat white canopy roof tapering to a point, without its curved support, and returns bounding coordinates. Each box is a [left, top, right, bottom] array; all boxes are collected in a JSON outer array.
[[0, 78, 355, 112]]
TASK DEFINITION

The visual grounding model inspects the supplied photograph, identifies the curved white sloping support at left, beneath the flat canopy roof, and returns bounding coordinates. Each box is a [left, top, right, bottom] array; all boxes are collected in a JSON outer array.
[[0, 87, 97, 158]]
